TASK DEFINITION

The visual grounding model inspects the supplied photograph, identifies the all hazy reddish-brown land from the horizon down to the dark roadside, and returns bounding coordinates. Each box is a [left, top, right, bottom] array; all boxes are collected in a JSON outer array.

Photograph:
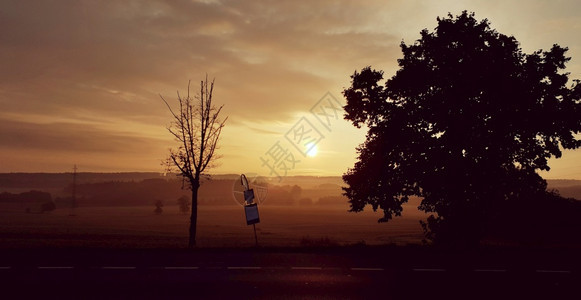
[[0, 173, 581, 248]]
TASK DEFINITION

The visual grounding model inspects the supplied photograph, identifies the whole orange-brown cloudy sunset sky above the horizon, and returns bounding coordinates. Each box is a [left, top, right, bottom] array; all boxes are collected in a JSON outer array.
[[0, 0, 581, 179]]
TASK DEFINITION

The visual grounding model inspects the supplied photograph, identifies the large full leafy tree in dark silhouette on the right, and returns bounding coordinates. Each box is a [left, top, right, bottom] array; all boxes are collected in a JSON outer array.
[[343, 11, 581, 245]]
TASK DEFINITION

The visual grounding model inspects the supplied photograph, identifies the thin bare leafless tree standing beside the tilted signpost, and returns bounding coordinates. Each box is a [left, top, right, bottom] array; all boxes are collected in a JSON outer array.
[[160, 75, 228, 248]]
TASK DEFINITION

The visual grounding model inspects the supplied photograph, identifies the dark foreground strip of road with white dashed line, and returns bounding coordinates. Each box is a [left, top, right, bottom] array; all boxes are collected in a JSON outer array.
[[0, 246, 581, 299]]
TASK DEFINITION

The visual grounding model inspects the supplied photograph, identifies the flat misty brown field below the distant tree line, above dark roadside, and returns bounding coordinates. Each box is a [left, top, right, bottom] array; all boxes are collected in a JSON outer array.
[[0, 201, 425, 248]]
